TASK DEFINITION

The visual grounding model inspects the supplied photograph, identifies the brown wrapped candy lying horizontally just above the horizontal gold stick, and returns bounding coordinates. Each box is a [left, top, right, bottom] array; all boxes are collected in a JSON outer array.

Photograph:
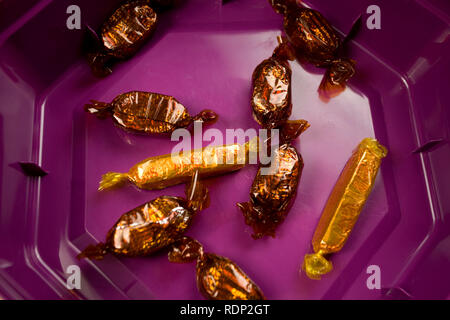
[[84, 91, 217, 134]]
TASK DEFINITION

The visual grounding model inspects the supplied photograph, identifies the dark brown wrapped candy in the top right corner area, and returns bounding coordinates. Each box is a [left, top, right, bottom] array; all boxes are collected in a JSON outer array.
[[269, 0, 361, 101]]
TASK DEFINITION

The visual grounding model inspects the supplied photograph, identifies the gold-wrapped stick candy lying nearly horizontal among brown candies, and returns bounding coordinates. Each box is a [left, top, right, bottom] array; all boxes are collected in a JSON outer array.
[[98, 137, 258, 191]]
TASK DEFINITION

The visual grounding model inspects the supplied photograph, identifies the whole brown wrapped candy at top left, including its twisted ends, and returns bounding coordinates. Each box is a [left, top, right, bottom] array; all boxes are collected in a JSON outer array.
[[87, 0, 177, 77]]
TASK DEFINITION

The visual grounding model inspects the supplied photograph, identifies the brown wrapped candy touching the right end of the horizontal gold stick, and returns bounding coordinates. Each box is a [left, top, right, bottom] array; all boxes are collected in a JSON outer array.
[[237, 120, 309, 239]]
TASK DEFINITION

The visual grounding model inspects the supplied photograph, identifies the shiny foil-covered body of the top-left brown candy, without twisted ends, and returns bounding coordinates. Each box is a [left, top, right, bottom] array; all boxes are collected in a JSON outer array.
[[101, 0, 157, 59]]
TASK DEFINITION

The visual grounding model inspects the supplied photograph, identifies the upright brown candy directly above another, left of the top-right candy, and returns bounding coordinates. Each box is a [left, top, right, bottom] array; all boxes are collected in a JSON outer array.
[[252, 38, 295, 129]]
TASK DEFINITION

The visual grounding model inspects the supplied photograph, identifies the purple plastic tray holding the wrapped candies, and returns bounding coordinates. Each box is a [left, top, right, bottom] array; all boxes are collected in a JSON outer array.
[[0, 0, 450, 299]]
